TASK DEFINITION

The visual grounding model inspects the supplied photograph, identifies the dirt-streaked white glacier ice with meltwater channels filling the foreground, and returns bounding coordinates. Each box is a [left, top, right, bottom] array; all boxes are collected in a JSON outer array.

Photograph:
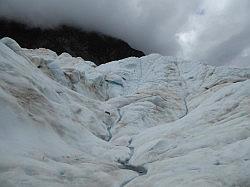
[[0, 38, 250, 187]]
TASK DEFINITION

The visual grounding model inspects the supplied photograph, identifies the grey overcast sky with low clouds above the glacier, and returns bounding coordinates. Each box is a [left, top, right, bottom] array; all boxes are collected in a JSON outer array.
[[0, 0, 250, 67]]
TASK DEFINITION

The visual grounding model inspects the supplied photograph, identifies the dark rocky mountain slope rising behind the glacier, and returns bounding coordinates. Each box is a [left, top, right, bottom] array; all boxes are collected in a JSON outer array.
[[0, 19, 144, 65]]
